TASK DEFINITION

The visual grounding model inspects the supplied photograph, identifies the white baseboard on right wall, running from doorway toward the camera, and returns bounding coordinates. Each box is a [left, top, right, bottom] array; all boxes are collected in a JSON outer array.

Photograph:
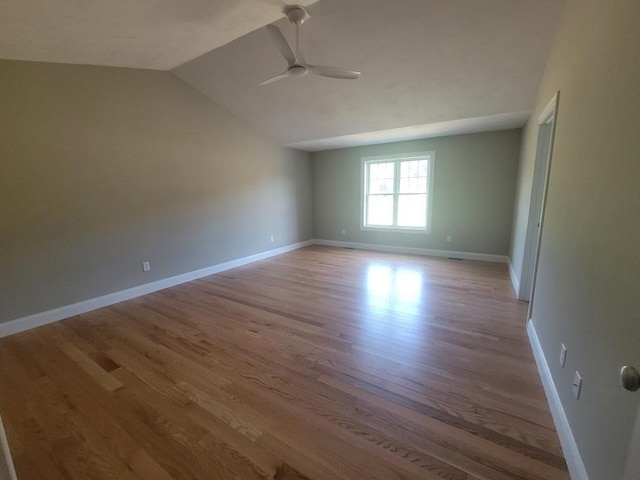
[[527, 319, 589, 480]]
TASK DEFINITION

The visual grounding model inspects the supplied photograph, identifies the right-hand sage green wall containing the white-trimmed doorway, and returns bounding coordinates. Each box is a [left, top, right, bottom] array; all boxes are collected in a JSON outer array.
[[513, 0, 640, 480]]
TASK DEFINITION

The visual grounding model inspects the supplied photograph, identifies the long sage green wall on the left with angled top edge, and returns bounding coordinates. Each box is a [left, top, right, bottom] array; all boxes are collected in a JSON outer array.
[[0, 61, 313, 321]]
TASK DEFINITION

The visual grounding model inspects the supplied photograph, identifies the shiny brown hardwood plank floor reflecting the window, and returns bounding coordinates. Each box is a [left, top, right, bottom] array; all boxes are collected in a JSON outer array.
[[0, 247, 569, 480]]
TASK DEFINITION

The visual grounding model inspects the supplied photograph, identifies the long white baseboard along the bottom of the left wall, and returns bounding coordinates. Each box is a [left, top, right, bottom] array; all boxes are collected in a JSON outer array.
[[0, 240, 315, 338]]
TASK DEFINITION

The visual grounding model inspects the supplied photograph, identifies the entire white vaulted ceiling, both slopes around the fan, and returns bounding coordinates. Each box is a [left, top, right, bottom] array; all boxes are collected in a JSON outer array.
[[0, 0, 565, 151]]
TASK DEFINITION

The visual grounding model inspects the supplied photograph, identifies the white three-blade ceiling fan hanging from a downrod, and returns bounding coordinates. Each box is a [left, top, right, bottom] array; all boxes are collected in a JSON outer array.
[[258, 5, 360, 85]]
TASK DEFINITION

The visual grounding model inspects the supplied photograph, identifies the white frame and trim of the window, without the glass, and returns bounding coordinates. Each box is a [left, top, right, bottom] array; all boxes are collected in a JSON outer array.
[[360, 150, 436, 234]]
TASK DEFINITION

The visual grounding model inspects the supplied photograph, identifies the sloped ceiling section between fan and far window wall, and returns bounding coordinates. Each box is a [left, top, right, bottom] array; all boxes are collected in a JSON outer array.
[[174, 0, 564, 150]]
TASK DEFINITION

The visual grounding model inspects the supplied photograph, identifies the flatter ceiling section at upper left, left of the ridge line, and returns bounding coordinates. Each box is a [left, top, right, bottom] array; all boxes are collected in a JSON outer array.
[[0, 0, 316, 70]]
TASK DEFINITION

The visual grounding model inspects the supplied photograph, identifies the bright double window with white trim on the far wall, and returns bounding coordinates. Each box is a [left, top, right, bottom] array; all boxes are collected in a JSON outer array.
[[362, 152, 435, 233]]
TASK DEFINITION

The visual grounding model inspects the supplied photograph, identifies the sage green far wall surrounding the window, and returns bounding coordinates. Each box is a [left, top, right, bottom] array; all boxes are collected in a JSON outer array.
[[312, 129, 521, 255]]
